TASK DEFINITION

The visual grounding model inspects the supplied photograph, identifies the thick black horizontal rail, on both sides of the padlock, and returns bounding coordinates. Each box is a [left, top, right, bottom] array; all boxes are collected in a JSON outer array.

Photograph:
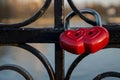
[[0, 24, 120, 44]]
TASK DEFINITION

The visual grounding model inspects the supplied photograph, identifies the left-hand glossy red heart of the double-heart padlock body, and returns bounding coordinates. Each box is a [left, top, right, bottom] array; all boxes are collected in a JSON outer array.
[[60, 28, 86, 54]]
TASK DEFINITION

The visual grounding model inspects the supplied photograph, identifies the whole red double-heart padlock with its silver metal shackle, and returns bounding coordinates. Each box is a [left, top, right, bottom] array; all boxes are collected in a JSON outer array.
[[60, 9, 109, 54]]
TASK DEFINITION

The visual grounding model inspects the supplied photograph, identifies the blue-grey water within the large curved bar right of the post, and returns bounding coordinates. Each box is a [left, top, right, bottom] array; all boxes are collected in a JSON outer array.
[[67, 49, 120, 80]]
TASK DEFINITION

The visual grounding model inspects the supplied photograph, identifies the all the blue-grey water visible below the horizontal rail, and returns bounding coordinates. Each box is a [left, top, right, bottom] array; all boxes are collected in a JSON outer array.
[[0, 44, 120, 80]]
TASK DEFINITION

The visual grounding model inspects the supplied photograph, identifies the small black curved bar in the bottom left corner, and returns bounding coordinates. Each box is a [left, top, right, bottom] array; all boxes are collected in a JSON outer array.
[[0, 64, 33, 80]]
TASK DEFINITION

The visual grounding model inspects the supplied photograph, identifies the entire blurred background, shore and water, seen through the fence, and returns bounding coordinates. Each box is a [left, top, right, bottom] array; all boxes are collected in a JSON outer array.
[[0, 0, 120, 80]]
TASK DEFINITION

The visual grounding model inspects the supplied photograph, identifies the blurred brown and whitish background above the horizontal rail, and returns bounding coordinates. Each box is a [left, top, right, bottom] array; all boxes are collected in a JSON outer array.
[[0, 0, 120, 26]]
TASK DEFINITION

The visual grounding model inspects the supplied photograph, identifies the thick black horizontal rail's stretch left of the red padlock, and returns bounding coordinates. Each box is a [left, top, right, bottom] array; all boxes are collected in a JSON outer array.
[[0, 28, 62, 43]]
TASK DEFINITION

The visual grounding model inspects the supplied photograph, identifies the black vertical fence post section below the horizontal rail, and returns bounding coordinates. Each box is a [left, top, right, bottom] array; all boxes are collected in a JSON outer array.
[[55, 43, 64, 80]]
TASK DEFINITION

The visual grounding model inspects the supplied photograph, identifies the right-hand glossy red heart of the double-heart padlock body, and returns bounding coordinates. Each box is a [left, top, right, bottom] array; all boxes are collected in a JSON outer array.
[[84, 26, 109, 53]]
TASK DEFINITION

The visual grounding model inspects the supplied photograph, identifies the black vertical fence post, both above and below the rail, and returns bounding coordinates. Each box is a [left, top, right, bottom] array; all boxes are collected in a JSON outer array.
[[54, 0, 64, 80]]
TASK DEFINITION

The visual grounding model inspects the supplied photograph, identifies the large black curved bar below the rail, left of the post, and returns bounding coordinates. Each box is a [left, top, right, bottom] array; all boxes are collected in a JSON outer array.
[[17, 44, 55, 80]]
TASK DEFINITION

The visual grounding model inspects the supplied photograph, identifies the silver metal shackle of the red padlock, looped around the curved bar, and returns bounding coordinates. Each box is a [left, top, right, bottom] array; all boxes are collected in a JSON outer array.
[[65, 8, 102, 30]]
